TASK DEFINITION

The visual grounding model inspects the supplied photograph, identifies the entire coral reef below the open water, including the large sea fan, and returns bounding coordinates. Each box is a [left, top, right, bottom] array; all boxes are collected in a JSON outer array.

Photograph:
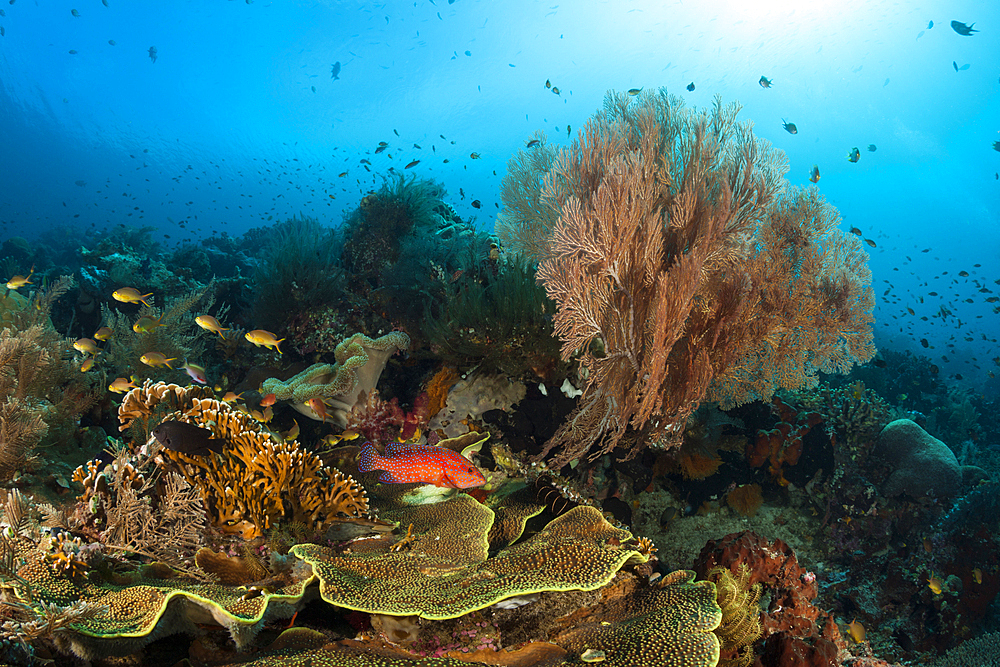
[[0, 61, 1000, 667]]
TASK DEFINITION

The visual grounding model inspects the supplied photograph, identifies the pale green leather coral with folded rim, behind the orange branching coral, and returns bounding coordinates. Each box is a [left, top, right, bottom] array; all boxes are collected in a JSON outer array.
[[262, 331, 410, 427]]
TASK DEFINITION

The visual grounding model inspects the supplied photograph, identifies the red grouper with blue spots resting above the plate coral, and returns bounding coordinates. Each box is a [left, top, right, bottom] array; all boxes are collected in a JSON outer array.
[[358, 442, 486, 489]]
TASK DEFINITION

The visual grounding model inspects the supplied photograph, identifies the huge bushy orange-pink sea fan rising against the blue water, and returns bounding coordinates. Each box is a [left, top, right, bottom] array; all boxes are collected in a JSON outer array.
[[498, 91, 874, 466]]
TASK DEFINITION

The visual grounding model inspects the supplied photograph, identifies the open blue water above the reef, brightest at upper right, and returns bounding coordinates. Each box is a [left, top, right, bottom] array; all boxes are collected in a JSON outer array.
[[0, 0, 1000, 380]]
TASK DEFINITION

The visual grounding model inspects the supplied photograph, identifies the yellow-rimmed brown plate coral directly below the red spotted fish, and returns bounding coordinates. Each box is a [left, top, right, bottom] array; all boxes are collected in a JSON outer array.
[[291, 494, 646, 620]]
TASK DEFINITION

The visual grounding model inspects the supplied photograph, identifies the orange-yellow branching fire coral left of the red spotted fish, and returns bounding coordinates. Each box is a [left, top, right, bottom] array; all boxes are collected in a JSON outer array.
[[119, 382, 368, 540]]
